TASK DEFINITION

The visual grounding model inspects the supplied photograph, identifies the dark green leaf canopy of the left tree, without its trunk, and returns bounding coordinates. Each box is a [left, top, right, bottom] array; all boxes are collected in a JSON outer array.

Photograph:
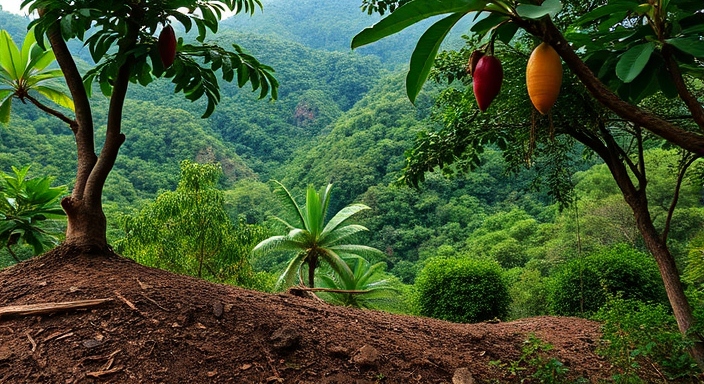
[[23, 0, 278, 117]]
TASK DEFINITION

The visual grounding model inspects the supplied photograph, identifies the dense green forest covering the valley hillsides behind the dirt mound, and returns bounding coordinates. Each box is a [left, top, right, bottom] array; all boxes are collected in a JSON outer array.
[[0, 0, 704, 375]]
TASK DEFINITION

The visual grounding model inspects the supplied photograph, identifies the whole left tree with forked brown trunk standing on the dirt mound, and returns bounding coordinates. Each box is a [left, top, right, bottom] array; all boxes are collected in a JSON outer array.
[[3, 0, 278, 253]]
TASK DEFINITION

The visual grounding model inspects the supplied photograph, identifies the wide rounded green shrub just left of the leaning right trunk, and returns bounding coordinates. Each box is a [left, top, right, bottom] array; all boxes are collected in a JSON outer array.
[[549, 245, 667, 316]]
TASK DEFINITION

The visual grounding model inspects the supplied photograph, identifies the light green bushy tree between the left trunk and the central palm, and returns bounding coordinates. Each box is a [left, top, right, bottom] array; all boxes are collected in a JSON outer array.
[[116, 160, 266, 285]]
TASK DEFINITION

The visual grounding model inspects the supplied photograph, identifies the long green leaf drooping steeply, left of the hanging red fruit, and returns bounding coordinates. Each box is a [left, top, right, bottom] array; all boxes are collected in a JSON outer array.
[[406, 12, 465, 103]]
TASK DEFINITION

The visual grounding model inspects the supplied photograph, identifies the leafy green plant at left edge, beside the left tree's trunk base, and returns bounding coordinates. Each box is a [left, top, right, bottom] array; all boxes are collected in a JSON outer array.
[[0, 166, 67, 262]]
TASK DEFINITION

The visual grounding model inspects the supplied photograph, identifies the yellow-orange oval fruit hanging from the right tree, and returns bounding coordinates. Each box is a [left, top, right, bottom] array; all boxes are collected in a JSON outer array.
[[526, 43, 562, 115]]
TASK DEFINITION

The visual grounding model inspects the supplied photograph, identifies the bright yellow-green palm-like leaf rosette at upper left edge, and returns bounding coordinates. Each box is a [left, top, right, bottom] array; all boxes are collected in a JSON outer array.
[[0, 30, 75, 124]]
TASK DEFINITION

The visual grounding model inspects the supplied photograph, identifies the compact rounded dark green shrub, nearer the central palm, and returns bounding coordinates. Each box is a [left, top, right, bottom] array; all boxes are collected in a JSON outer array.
[[414, 258, 510, 323]]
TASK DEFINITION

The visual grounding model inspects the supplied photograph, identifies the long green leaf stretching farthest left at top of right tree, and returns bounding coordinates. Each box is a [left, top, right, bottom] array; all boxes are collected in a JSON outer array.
[[352, 0, 487, 49]]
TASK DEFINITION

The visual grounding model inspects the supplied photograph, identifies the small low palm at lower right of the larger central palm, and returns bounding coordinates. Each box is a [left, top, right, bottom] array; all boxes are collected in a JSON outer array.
[[318, 256, 401, 310]]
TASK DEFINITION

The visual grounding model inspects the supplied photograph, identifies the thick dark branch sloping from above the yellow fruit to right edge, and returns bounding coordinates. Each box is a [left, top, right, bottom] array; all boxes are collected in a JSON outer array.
[[513, 17, 704, 155]]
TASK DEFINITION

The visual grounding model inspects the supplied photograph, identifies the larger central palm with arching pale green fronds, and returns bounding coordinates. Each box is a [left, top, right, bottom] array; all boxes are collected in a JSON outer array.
[[253, 181, 382, 289]]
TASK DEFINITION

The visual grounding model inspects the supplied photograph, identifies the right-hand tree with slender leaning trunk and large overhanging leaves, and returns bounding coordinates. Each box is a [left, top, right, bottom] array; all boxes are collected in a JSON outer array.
[[352, 0, 704, 368]]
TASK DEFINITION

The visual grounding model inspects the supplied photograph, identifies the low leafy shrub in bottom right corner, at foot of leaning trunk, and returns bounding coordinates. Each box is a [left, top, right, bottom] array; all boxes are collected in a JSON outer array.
[[595, 297, 698, 383]]
